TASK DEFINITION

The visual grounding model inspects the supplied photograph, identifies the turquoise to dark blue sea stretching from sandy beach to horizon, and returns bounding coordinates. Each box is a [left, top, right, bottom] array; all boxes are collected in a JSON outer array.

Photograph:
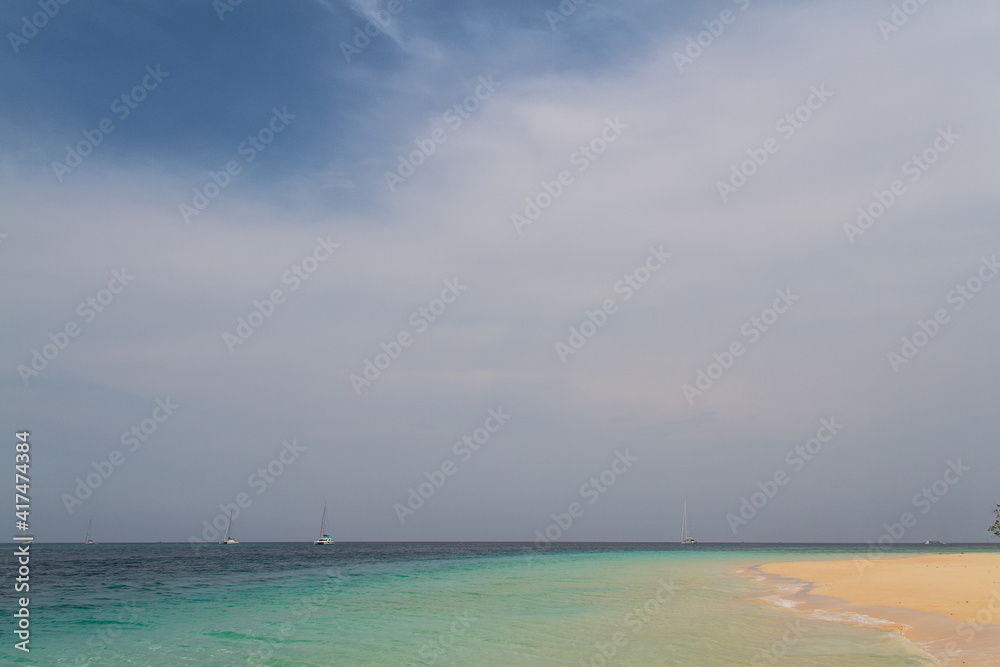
[[0, 543, 995, 667]]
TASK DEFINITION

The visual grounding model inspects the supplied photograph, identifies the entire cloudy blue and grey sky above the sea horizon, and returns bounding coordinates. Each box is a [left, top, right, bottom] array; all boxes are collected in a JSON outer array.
[[0, 0, 1000, 545]]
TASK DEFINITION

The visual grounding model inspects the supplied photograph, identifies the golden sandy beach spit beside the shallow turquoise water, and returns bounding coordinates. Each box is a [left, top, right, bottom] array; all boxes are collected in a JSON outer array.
[[746, 553, 1000, 665]]
